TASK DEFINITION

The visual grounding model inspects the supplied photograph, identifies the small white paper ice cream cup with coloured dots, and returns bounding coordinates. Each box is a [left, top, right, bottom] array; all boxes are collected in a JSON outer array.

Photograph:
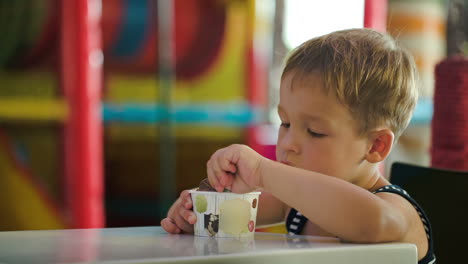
[[190, 191, 260, 238]]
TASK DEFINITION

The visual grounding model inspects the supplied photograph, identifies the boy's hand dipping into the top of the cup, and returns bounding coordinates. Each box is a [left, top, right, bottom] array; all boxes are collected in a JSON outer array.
[[207, 145, 265, 193]]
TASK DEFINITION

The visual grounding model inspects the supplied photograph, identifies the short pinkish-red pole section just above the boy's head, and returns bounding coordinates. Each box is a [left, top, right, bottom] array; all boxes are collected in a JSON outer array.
[[364, 0, 388, 32]]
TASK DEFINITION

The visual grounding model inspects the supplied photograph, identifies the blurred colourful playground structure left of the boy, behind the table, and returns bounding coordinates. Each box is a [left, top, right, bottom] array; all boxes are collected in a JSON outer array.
[[0, 0, 272, 230]]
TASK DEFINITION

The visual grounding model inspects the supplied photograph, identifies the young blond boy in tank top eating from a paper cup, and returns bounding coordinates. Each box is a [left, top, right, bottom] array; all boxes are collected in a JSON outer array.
[[161, 29, 435, 263]]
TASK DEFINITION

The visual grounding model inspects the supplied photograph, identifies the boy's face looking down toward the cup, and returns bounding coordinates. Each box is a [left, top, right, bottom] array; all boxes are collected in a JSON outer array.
[[276, 72, 370, 183]]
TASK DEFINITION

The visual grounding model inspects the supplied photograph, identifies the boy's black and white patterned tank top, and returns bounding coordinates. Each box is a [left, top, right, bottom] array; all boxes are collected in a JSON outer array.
[[286, 185, 436, 264]]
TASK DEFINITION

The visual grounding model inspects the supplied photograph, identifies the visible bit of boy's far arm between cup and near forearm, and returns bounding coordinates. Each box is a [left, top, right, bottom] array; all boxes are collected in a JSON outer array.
[[257, 191, 286, 225]]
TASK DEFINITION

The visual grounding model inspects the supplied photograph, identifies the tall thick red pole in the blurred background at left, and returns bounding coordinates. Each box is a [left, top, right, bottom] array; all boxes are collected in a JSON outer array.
[[61, 0, 104, 228]]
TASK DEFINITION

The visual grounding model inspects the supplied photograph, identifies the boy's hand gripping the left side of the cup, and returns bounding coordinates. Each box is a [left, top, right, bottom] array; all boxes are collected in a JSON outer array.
[[161, 190, 197, 234]]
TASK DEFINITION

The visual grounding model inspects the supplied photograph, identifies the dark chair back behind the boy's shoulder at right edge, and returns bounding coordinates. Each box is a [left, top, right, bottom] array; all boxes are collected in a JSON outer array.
[[390, 162, 468, 264]]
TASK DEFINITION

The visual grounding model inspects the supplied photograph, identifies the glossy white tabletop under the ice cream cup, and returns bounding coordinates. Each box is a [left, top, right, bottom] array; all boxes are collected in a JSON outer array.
[[0, 227, 417, 264]]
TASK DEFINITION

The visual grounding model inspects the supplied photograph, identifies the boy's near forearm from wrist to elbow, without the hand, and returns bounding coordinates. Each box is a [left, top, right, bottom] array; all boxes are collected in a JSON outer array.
[[260, 158, 398, 241]]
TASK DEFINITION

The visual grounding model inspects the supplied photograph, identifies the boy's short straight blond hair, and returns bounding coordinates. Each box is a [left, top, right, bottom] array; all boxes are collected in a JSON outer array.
[[283, 29, 418, 139]]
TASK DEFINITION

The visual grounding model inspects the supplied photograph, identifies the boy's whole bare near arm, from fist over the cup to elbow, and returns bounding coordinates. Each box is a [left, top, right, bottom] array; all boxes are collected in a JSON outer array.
[[207, 144, 406, 242]]
